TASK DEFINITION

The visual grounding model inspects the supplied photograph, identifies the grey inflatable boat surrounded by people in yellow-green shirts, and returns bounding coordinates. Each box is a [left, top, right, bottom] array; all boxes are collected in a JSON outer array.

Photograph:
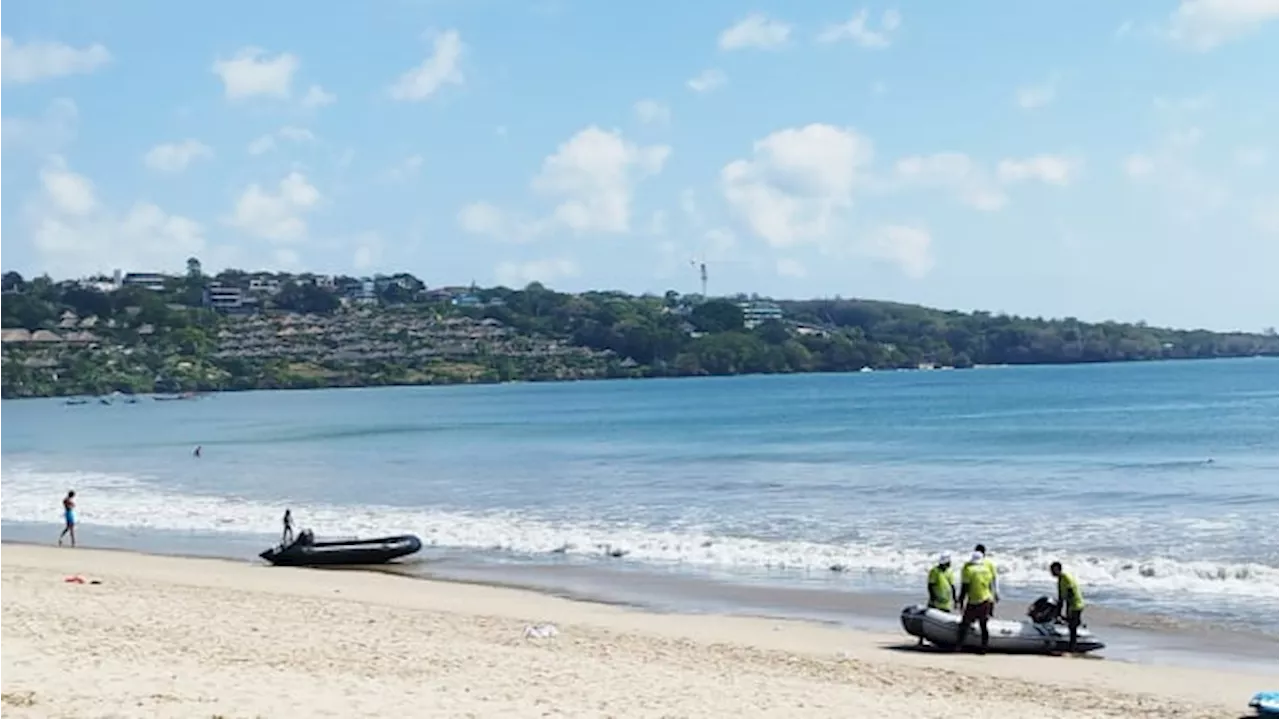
[[901, 597, 1106, 654]]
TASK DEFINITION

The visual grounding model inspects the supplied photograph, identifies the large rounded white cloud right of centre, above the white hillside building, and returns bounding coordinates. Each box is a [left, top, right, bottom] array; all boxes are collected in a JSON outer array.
[[721, 124, 873, 247]]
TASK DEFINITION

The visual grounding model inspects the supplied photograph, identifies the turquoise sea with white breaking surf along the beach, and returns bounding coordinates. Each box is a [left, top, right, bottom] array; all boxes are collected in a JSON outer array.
[[0, 360, 1280, 627]]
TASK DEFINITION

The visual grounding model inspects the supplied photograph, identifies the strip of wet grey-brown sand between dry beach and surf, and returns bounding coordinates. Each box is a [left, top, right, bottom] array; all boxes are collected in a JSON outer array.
[[0, 523, 1275, 673]]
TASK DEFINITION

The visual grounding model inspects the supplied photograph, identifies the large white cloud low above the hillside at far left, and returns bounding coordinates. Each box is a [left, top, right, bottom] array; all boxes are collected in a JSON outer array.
[[27, 156, 206, 275]]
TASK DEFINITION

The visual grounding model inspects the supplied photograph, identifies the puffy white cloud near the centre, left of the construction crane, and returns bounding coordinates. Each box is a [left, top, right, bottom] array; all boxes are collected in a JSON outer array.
[[532, 125, 671, 233]]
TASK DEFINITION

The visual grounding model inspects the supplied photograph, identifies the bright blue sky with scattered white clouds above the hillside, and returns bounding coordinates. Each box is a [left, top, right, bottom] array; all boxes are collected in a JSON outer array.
[[0, 0, 1280, 330]]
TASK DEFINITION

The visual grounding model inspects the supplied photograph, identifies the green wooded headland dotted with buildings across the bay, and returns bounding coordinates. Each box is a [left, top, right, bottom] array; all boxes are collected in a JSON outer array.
[[0, 258, 1280, 398]]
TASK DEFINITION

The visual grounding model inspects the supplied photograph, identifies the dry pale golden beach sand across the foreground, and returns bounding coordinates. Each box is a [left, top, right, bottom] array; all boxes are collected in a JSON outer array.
[[0, 545, 1276, 719]]
